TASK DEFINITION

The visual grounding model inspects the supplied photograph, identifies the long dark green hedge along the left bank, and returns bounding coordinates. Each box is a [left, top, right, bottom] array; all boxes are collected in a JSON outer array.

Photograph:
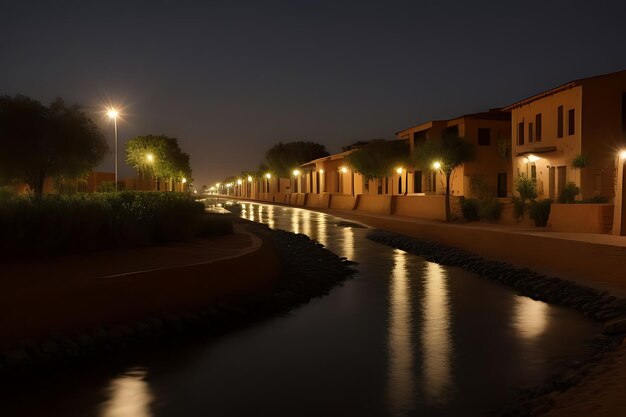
[[0, 191, 232, 257]]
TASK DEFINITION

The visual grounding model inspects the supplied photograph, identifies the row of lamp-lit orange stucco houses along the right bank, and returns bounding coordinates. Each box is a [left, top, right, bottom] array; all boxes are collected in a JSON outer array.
[[222, 70, 626, 234]]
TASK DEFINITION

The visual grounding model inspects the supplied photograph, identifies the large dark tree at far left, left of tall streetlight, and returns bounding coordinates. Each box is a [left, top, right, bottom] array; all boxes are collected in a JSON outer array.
[[0, 95, 108, 196]]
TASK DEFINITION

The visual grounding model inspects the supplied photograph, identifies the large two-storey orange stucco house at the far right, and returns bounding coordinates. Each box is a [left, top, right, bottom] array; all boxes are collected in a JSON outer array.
[[503, 70, 626, 200]]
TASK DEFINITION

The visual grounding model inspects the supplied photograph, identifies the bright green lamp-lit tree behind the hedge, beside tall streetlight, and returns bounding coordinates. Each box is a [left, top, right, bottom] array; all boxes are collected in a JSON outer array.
[[126, 135, 191, 189]]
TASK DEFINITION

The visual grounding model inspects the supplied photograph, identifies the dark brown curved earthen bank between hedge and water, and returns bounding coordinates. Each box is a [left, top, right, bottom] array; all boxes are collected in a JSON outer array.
[[0, 218, 352, 371]]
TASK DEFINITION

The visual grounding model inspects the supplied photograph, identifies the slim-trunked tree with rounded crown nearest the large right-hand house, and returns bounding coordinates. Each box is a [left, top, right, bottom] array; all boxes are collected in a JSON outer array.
[[411, 135, 475, 221]]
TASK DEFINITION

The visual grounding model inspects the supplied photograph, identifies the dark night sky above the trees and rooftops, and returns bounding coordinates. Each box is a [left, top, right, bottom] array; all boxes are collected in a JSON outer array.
[[0, 0, 626, 186]]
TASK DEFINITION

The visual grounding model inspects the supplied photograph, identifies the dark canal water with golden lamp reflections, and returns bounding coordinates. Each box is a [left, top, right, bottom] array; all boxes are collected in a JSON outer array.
[[0, 203, 598, 417]]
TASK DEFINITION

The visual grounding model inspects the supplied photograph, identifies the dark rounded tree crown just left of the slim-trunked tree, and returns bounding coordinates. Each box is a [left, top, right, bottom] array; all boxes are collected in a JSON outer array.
[[346, 140, 409, 192]]
